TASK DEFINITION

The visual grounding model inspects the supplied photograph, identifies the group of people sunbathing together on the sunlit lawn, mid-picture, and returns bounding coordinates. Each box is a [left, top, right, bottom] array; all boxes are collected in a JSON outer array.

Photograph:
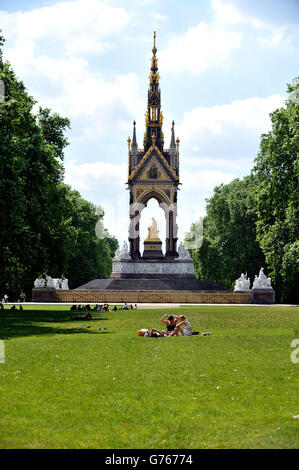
[[137, 314, 194, 338]]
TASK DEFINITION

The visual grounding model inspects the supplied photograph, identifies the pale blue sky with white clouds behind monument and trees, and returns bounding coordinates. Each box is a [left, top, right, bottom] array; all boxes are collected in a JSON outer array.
[[0, 0, 299, 250]]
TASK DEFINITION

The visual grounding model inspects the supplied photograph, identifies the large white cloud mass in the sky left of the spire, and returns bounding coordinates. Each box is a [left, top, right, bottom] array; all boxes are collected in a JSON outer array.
[[0, 0, 144, 138]]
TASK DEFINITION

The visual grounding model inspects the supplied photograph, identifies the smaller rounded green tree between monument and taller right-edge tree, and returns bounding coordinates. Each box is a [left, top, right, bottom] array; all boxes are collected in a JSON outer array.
[[190, 176, 265, 289]]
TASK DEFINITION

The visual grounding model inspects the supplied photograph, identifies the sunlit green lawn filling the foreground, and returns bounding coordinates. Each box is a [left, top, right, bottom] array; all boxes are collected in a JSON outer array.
[[0, 305, 299, 449]]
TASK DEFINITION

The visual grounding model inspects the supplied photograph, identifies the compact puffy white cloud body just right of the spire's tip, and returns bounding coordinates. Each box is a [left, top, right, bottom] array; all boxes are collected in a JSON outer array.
[[159, 22, 242, 75]]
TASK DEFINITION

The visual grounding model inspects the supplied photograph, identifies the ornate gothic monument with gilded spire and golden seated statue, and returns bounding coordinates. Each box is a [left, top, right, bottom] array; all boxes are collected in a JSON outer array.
[[111, 33, 195, 279]]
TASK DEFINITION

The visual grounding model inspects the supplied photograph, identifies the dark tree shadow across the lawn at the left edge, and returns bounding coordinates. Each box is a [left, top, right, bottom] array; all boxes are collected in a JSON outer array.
[[0, 309, 110, 339]]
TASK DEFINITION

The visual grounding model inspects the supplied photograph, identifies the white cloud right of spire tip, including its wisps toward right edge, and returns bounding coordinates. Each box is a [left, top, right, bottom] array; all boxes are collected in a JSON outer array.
[[159, 0, 291, 75]]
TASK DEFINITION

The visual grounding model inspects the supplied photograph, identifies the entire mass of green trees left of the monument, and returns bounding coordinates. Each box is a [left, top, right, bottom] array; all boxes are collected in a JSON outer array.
[[0, 32, 117, 296]]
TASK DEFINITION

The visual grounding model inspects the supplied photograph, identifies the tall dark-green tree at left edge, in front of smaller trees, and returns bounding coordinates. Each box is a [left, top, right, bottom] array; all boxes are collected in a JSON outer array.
[[0, 39, 69, 293]]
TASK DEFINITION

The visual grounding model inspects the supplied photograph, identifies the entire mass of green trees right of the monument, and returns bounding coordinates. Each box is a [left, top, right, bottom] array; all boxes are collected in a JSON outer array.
[[190, 79, 299, 302]]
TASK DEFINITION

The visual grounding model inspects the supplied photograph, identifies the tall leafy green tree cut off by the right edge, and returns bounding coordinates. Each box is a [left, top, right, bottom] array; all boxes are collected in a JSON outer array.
[[253, 79, 299, 302]]
